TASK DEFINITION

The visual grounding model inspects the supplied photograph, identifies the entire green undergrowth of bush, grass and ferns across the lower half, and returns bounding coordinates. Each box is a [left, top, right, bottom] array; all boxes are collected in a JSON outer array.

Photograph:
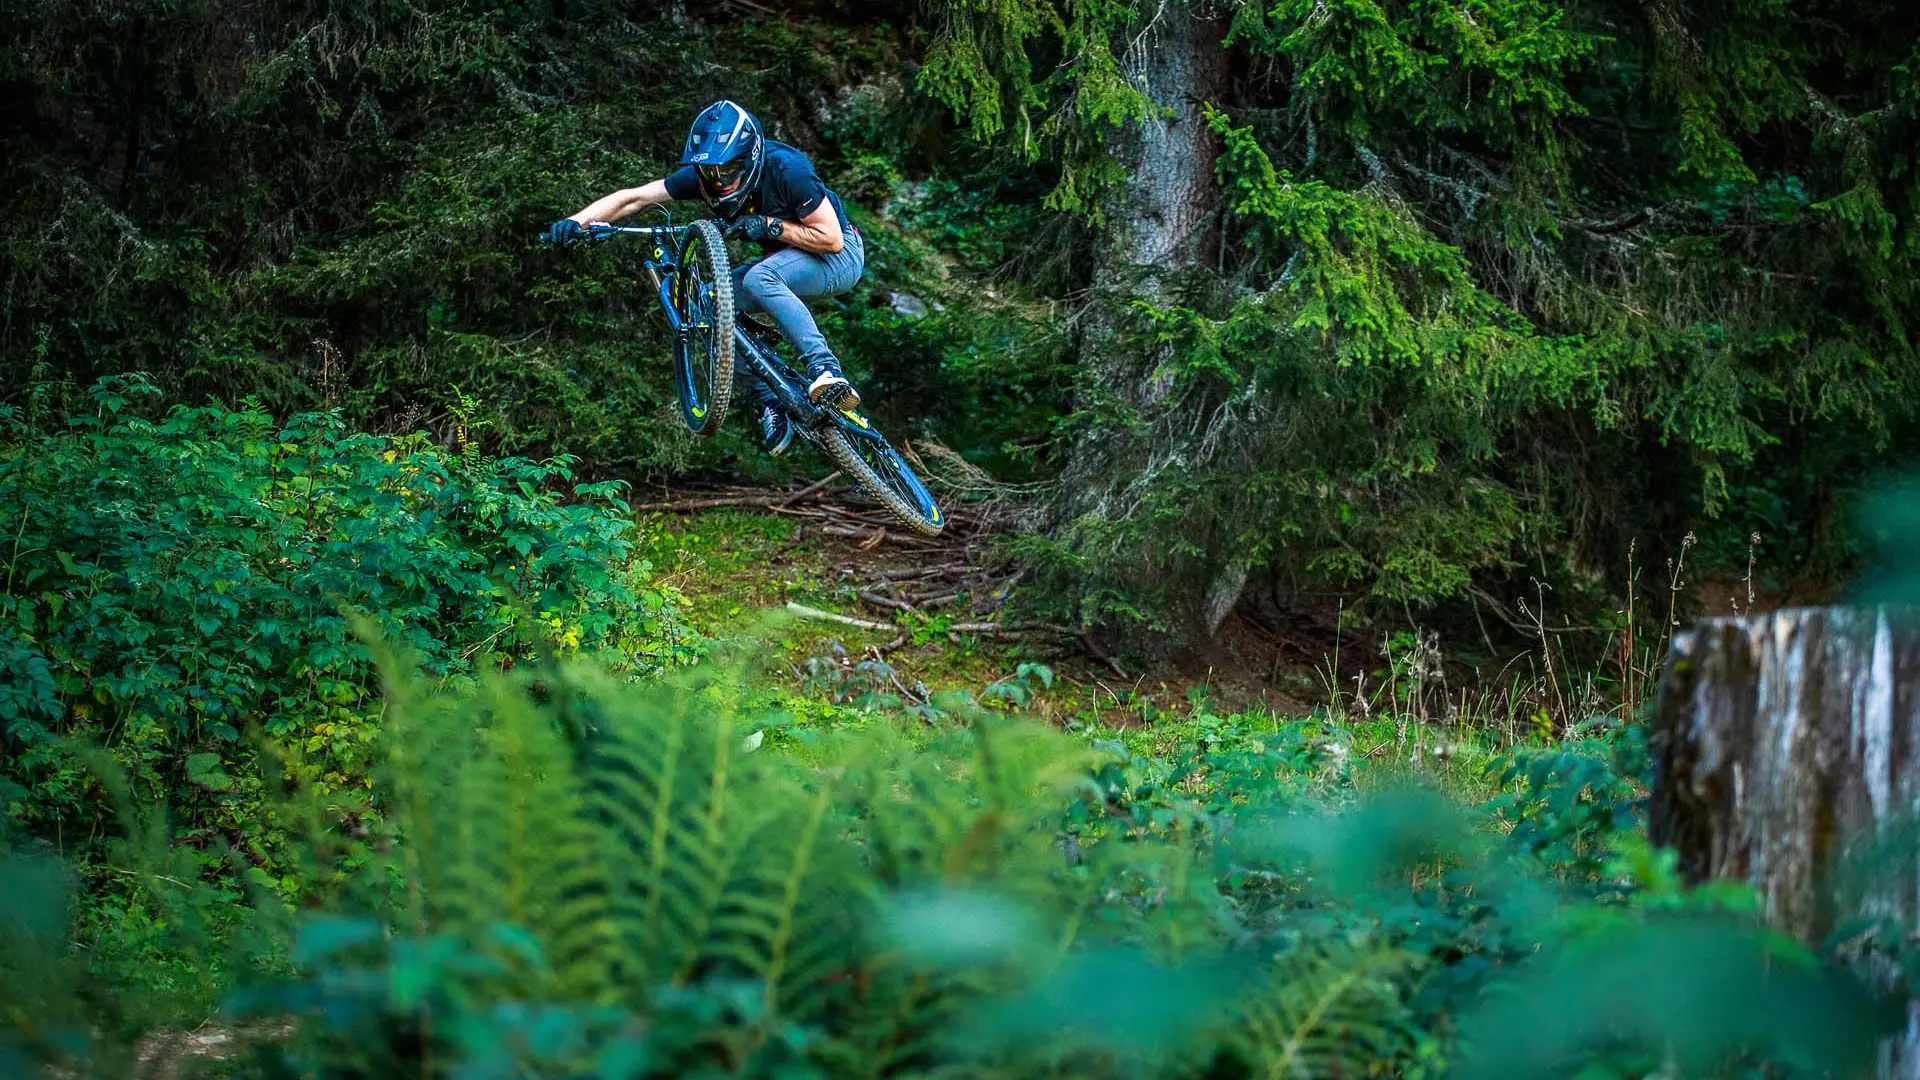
[[0, 380, 1904, 1080]]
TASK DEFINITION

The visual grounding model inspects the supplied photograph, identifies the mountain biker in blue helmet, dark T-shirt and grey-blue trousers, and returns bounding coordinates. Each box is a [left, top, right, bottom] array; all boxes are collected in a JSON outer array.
[[547, 100, 866, 455]]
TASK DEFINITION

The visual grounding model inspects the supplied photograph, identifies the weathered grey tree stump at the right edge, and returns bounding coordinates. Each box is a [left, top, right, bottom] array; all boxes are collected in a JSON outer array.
[[1649, 607, 1920, 1080]]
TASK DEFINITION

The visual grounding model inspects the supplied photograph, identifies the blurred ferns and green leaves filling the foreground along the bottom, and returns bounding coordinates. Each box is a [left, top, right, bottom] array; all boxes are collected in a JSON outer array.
[[0, 625, 1899, 1078]]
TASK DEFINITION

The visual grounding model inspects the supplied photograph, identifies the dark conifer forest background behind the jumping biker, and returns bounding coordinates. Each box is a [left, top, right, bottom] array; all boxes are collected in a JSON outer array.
[[15, 0, 1920, 638]]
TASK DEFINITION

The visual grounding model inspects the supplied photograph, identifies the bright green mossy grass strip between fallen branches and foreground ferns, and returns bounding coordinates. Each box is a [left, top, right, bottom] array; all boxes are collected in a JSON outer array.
[[641, 509, 1574, 799]]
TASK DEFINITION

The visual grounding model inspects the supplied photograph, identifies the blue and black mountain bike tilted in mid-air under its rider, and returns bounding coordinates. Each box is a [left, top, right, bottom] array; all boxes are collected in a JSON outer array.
[[568, 219, 947, 536]]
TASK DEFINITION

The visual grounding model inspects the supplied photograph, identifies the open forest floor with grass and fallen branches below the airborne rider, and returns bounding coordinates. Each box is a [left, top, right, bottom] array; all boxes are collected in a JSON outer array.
[[636, 484, 1551, 796]]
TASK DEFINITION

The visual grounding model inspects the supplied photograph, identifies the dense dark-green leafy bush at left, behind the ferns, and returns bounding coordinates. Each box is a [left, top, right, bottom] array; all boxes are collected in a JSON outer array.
[[0, 379, 684, 857]]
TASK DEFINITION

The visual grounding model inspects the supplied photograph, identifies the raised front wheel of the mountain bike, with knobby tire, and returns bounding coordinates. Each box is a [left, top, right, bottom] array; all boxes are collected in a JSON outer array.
[[672, 221, 733, 434]]
